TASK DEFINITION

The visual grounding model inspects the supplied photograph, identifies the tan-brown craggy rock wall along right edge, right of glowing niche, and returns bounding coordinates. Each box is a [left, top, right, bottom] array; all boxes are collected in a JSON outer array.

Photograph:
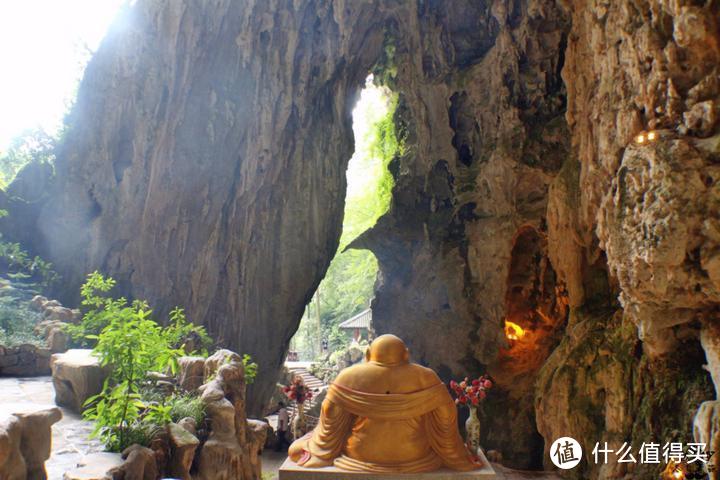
[[536, 1, 720, 478]]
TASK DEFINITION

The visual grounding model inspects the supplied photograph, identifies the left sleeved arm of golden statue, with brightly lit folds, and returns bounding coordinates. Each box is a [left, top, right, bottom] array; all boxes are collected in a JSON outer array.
[[289, 399, 355, 468]]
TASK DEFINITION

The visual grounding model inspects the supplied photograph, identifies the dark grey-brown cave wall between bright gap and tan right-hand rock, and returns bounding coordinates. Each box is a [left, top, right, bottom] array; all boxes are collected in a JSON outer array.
[[354, 0, 570, 468]]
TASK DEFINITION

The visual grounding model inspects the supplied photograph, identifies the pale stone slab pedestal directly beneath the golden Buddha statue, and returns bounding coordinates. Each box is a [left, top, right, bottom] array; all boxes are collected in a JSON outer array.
[[279, 452, 495, 480]]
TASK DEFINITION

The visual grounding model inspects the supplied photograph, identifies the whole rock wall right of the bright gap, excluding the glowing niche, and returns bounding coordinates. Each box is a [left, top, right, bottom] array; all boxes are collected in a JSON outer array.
[[357, 0, 719, 478]]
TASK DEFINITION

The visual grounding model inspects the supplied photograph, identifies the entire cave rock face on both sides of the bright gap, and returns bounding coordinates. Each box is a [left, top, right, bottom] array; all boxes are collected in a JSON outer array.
[[7, 0, 720, 478]]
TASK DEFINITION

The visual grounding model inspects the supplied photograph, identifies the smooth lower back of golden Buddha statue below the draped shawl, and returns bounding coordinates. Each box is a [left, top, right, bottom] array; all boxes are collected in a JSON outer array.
[[344, 418, 434, 464]]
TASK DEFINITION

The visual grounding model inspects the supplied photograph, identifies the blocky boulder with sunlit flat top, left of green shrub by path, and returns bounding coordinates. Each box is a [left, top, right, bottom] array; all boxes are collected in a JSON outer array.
[[50, 349, 107, 412]]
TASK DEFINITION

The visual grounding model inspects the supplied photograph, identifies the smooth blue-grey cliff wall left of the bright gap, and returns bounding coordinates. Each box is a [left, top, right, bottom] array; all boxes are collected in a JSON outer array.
[[19, 0, 383, 413]]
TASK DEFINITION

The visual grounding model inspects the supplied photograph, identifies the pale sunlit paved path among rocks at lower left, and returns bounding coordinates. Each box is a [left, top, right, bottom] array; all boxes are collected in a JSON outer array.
[[0, 377, 103, 480]]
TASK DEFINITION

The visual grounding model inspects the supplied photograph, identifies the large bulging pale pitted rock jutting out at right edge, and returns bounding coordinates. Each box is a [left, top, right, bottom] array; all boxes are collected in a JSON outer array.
[[598, 137, 720, 354]]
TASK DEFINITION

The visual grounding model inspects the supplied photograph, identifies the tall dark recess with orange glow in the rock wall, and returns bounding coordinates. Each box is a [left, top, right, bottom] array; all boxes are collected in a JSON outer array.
[[486, 225, 568, 470]]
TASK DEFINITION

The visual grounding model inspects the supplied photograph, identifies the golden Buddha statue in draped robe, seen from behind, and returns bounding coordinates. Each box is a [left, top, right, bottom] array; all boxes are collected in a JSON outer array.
[[289, 335, 482, 473]]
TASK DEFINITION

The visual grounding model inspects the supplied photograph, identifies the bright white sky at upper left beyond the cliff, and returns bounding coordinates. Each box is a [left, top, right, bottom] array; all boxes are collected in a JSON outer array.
[[0, 0, 127, 151]]
